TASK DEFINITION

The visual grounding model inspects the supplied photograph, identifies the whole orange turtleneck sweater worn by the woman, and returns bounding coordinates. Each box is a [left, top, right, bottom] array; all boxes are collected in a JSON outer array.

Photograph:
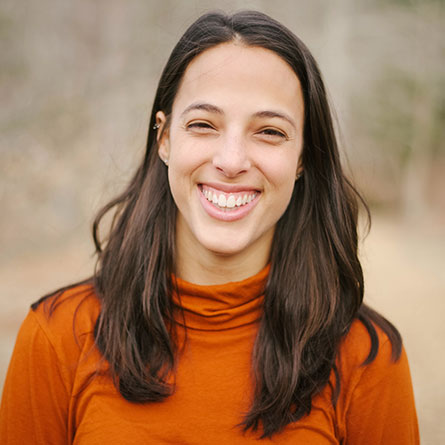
[[0, 268, 419, 445]]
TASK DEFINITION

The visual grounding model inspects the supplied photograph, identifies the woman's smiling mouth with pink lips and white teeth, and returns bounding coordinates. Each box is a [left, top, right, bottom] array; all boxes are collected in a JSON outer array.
[[198, 184, 261, 221]]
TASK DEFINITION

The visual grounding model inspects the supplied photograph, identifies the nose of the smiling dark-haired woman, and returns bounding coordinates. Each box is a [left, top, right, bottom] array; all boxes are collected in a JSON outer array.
[[213, 135, 251, 178]]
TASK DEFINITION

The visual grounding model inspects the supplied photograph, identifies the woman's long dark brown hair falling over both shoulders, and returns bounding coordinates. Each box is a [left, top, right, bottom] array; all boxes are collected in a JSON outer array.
[[33, 11, 401, 437]]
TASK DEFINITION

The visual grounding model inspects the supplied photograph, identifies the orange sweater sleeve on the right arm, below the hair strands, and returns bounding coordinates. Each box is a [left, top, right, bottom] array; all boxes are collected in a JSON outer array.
[[345, 338, 419, 445]]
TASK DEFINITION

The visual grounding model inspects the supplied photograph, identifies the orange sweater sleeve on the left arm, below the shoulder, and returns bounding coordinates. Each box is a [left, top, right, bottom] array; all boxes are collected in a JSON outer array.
[[0, 311, 70, 445]]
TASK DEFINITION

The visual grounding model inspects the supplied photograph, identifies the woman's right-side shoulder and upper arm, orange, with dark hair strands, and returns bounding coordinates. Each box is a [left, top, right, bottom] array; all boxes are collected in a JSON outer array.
[[336, 319, 419, 444]]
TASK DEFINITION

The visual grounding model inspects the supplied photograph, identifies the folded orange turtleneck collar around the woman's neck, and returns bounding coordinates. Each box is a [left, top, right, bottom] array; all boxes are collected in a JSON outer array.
[[173, 265, 270, 331]]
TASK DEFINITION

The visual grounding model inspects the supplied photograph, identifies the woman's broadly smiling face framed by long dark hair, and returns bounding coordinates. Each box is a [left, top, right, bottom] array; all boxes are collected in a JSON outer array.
[[157, 43, 304, 278]]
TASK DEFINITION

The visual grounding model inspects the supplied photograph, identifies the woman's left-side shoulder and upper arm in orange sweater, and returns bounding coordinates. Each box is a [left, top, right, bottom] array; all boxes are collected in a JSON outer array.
[[0, 284, 100, 436]]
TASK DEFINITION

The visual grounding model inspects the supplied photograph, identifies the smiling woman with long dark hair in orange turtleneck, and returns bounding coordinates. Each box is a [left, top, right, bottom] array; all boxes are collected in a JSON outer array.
[[0, 11, 419, 444]]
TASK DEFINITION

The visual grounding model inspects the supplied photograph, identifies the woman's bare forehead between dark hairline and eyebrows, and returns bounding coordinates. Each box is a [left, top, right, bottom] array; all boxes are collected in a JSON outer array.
[[173, 42, 303, 120]]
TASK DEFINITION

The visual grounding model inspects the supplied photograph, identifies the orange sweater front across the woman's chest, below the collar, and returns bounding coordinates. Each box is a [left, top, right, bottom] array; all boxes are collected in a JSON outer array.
[[72, 328, 338, 445]]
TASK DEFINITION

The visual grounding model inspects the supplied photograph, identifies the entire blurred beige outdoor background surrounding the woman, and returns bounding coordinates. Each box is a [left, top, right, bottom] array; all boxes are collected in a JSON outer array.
[[0, 0, 445, 445]]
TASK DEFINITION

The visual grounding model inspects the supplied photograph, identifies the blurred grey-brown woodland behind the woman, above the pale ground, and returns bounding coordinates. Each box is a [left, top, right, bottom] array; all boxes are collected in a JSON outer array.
[[0, 0, 445, 255]]
